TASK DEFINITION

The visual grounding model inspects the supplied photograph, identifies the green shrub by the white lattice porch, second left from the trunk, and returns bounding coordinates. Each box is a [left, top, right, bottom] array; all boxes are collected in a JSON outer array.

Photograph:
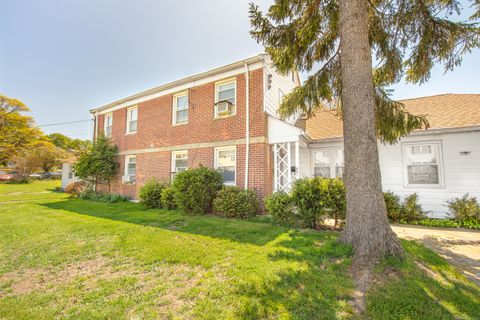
[[291, 177, 325, 229]]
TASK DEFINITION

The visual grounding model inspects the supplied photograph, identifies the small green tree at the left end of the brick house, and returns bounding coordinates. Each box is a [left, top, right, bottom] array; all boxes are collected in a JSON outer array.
[[75, 136, 118, 190]]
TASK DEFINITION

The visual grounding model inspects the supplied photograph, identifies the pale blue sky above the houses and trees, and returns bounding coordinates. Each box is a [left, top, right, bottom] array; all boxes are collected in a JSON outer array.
[[0, 0, 480, 138]]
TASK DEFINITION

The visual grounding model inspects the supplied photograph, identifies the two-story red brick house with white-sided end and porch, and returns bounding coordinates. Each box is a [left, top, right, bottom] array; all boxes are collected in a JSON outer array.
[[91, 54, 300, 197]]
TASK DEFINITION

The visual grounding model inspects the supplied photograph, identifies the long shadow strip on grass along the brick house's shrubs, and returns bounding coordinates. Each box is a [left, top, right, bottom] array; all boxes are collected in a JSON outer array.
[[42, 199, 287, 245]]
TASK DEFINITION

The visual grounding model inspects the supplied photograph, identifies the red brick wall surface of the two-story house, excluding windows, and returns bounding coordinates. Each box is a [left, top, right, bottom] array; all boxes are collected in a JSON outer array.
[[98, 69, 272, 197]]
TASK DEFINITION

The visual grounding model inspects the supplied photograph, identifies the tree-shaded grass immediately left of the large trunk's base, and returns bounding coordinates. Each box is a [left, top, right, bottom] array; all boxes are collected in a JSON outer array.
[[231, 231, 354, 319]]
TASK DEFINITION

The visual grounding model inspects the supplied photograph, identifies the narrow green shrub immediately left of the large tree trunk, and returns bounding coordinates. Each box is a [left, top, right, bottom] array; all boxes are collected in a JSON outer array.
[[320, 178, 347, 228]]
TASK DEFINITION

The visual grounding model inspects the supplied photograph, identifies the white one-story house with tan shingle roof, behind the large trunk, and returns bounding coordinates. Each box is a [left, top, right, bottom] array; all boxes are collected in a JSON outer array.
[[304, 94, 480, 218]]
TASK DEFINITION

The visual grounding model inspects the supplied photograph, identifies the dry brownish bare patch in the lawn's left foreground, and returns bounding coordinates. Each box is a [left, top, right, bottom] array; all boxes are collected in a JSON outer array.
[[0, 256, 209, 314]]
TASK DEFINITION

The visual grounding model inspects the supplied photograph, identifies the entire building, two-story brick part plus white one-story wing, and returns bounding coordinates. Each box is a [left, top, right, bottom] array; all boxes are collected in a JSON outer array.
[[91, 54, 480, 217]]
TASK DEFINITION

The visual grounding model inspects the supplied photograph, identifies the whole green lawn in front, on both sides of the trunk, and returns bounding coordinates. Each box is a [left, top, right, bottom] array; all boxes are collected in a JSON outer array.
[[0, 182, 480, 320]]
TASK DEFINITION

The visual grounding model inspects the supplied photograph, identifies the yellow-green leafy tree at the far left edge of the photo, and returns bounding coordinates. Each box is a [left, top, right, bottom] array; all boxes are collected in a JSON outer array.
[[0, 95, 42, 165]]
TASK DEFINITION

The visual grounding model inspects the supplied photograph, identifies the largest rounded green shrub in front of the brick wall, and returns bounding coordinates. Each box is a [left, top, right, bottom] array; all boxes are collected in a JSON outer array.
[[172, 166, 223, 214]]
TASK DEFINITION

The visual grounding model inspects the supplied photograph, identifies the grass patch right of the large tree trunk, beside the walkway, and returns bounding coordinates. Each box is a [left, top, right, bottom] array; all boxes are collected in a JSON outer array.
[[367, 240, 480, 320]]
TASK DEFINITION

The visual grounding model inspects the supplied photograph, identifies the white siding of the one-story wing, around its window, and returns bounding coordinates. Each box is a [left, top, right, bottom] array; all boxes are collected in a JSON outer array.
[[309, 131, 480, 218]]
